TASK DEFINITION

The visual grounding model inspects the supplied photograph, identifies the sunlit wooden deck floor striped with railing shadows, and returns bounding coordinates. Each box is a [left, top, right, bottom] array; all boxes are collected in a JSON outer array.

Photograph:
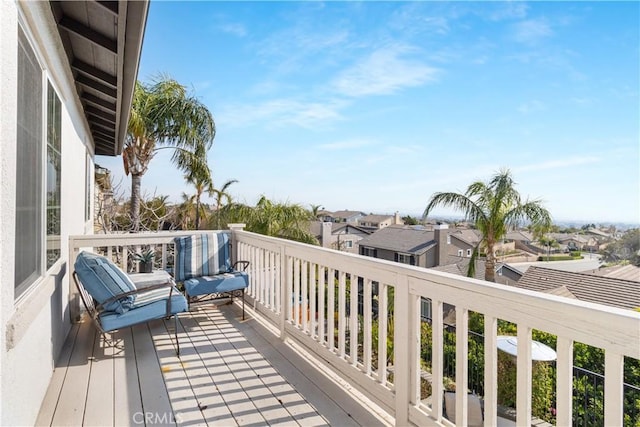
[[37, 306, 390, 426]]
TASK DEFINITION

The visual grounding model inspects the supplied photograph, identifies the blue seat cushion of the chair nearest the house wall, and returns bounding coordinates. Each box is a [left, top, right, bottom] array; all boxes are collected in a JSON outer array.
[[100, 287, 187, 332]]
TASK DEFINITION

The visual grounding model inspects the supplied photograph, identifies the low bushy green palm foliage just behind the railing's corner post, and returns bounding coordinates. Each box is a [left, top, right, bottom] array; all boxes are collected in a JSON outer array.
[[223, 196, 318, 245]]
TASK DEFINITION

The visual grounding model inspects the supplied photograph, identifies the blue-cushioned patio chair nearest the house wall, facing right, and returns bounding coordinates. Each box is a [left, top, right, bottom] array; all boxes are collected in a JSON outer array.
[[73, 251, 187, 355]]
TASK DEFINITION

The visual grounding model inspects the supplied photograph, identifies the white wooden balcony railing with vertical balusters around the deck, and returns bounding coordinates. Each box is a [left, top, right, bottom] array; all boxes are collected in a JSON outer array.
[[69, 230, 640, 426]]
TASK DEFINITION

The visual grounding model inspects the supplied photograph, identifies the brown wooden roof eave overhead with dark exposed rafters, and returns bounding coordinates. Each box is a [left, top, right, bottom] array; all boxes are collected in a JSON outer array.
[[49, 0, 149, 156]]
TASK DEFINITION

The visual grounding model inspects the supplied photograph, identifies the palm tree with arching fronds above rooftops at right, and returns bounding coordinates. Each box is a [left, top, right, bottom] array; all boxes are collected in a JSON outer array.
[[423, 169, 551, 282]]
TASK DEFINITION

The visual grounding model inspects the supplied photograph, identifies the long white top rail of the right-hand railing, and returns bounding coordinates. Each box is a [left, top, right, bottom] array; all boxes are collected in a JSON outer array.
[[235, 231, 640, 359]]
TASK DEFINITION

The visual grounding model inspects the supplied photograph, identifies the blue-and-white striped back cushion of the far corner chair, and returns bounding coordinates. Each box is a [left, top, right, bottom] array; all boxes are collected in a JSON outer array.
[[174, 233, 231, 282]]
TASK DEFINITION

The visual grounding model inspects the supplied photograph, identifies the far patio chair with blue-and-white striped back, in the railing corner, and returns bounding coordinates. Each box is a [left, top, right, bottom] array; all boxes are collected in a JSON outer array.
[[174, 232, 249, 320]]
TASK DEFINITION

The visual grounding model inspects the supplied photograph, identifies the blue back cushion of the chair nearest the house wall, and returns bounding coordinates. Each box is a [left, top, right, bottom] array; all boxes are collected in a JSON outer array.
[[75, 251, 136, 314]]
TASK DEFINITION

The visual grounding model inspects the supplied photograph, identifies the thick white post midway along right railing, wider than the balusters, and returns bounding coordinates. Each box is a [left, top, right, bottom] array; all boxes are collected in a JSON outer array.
[[393, 275, 412, 426]]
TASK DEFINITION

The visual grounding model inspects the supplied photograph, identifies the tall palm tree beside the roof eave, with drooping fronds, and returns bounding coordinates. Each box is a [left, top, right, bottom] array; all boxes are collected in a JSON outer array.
[[122, 76, 216, 231]]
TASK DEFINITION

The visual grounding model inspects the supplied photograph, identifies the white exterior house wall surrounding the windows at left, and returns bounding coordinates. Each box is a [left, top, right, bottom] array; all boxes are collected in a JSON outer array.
[[0, 1, 93, 425]]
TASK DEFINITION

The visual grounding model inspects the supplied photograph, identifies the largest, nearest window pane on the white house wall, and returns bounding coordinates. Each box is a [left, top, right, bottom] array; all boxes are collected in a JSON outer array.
[[14, 28, 44, 297]]
